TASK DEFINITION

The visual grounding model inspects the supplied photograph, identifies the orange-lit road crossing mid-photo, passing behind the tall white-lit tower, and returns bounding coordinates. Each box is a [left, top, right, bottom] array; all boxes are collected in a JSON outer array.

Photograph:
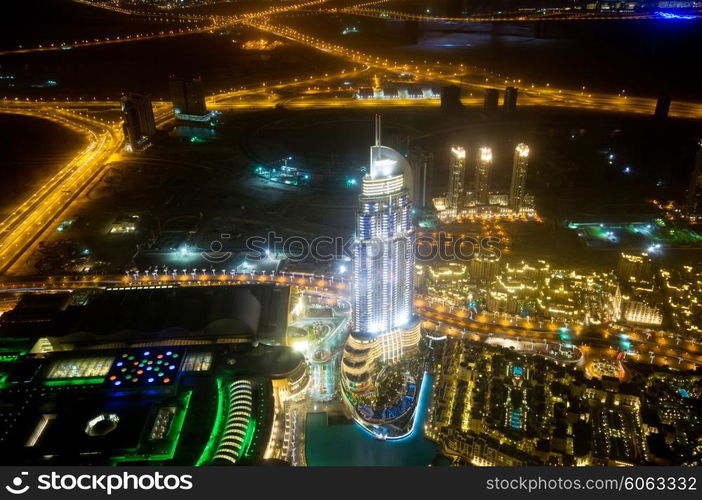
[[0, 270, 702, 370]]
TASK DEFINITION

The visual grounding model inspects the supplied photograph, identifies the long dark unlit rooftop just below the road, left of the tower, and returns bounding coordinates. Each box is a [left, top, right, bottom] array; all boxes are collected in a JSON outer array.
[[0, 285, 289, 345]]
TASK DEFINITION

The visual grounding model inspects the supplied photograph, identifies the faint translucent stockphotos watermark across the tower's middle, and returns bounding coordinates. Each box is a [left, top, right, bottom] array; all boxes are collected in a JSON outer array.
[[201, 232, 502, 264]]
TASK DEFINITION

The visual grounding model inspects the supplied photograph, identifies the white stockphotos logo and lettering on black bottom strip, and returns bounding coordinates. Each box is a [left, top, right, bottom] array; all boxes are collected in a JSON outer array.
[[5, 471, 193, 495]]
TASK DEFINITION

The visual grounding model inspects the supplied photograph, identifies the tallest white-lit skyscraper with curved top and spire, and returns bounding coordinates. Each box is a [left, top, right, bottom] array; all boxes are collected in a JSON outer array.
[[342, 115, 420, 392]]
